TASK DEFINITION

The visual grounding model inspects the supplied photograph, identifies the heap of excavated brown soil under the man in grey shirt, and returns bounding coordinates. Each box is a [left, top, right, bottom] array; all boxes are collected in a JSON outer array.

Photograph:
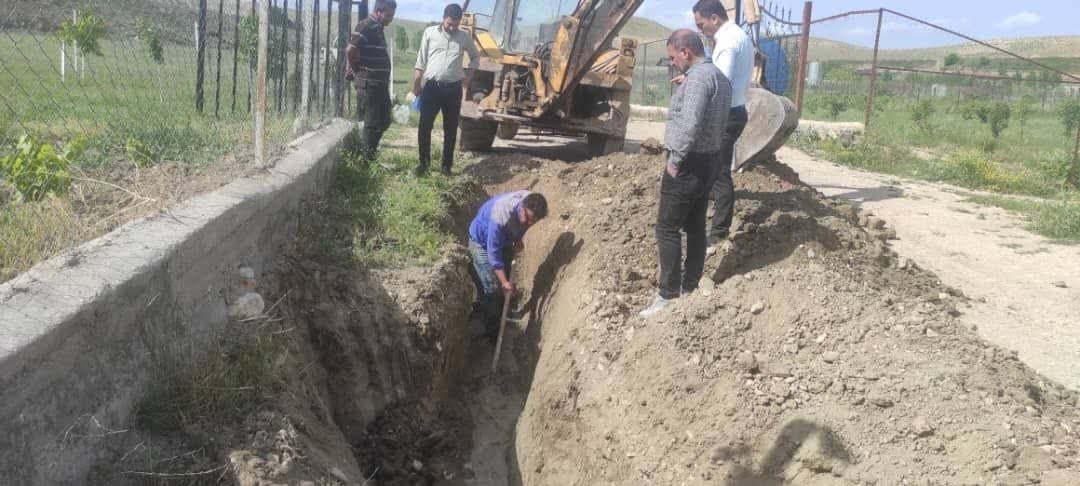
[[467, 150, 1080, 485]]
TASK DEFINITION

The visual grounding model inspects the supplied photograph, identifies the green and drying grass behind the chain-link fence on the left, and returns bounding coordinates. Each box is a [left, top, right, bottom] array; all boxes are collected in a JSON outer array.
[[0, 31, 304, 282]]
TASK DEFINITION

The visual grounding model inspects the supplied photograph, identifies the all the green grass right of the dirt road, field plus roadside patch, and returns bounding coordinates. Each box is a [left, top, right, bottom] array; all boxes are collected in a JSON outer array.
[[792, 99, 1080, 242]]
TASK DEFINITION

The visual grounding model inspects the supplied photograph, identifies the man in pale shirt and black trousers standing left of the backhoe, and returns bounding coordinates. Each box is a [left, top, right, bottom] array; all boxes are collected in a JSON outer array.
[[413, 3, 480, 176]]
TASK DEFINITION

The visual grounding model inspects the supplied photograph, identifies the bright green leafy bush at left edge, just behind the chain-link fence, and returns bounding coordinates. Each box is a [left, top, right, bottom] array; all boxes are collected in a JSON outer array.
[[0, 135, 85, 201]]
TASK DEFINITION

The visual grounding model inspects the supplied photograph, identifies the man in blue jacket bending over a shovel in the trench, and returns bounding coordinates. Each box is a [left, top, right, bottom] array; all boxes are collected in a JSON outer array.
[[469, 191, 548, 333]]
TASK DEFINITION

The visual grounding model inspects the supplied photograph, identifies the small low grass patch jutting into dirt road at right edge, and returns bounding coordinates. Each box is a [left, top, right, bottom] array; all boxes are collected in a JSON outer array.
[[969, 195, 1080, 239]]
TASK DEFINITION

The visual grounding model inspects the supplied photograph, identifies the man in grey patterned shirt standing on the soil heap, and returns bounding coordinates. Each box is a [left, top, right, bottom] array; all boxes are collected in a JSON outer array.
[[640, 29, 731, 318]]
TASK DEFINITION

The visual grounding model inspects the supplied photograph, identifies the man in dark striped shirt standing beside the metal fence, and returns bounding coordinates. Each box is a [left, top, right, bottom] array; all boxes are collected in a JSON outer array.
[[345, 0, 397, 160]]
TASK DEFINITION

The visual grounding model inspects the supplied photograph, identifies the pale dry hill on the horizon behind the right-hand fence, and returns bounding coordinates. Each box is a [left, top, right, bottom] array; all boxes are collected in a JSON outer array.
[[809, 36, 1080, 62]]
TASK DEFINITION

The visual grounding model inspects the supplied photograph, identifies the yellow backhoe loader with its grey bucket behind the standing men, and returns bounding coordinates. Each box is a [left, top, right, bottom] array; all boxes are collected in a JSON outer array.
[[459, 0, 798, 163]]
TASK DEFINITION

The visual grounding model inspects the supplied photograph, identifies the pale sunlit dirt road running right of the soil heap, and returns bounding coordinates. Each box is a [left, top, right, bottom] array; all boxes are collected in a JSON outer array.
[[631, 122, 1080, 389]]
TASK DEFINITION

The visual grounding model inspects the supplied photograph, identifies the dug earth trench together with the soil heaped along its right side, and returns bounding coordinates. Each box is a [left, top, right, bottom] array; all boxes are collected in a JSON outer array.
[[92, 147, 1080, 485]]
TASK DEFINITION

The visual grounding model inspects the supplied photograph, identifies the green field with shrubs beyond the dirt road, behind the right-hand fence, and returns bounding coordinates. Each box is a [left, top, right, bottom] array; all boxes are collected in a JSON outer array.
[[795, 93, 1074, 198]]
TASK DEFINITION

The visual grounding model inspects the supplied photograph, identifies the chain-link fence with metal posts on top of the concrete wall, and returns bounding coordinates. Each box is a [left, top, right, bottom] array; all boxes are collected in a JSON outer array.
[[0, 0, 380, 282]]
